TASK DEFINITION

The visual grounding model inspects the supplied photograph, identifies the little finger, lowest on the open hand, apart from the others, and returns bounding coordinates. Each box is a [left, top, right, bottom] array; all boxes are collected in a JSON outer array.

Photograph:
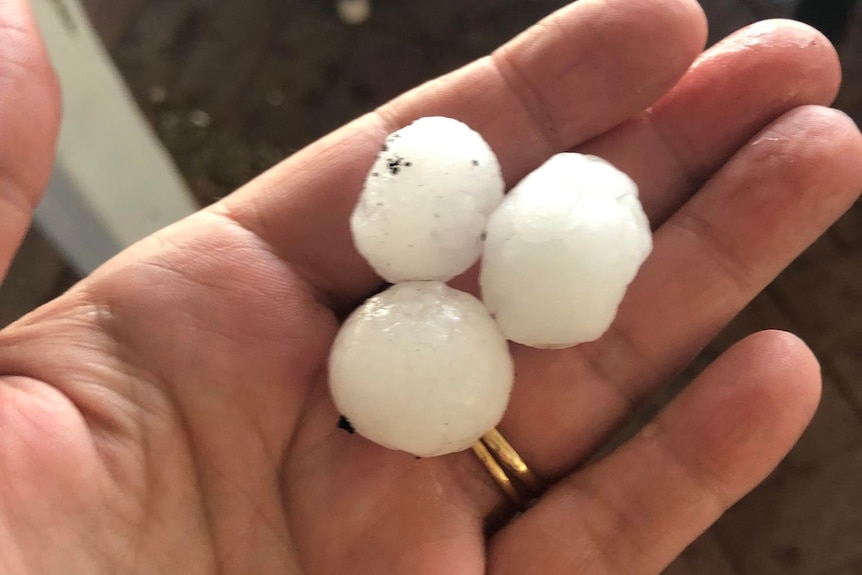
[[489, 332, 820, 575]]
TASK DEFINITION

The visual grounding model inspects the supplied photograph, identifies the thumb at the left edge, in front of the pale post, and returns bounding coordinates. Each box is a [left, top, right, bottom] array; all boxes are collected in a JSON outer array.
[[0, 0, 60, 281]]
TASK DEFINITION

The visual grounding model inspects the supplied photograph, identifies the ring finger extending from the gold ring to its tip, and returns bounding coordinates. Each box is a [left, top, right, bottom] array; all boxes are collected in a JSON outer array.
[[502, 106, 862, 478]]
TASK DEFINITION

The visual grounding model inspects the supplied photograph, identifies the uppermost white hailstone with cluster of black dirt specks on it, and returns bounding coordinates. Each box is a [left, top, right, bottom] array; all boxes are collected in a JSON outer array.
[[350, 117, 505, 283]]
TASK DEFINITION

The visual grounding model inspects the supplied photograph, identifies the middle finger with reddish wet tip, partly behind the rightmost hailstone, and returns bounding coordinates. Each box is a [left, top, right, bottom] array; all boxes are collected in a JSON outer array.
[[578, 20, 841, 228]]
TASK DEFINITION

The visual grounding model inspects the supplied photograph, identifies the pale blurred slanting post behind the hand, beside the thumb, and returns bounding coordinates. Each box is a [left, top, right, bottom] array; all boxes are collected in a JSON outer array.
[[31, 0, 196, 274]]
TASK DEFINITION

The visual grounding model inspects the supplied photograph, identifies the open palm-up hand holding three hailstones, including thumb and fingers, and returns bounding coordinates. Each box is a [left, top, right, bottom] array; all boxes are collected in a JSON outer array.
[[0, 0, 862, 575]]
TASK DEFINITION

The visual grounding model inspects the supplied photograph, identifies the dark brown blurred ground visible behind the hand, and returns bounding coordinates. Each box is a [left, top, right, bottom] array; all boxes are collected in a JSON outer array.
[[0, 0, 862, 575]]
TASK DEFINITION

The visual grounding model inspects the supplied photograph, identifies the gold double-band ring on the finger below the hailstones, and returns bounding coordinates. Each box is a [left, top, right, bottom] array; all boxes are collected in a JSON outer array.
[[473, 429, 545, 510]]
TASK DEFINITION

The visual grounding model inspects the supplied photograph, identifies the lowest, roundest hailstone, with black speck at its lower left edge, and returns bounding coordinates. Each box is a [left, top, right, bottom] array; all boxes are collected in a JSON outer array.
[[329, 281, 514, 457]]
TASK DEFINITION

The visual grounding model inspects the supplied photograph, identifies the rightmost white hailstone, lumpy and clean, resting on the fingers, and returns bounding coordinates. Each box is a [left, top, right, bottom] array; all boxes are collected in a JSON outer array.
[[480, 153, 652, 348]]
